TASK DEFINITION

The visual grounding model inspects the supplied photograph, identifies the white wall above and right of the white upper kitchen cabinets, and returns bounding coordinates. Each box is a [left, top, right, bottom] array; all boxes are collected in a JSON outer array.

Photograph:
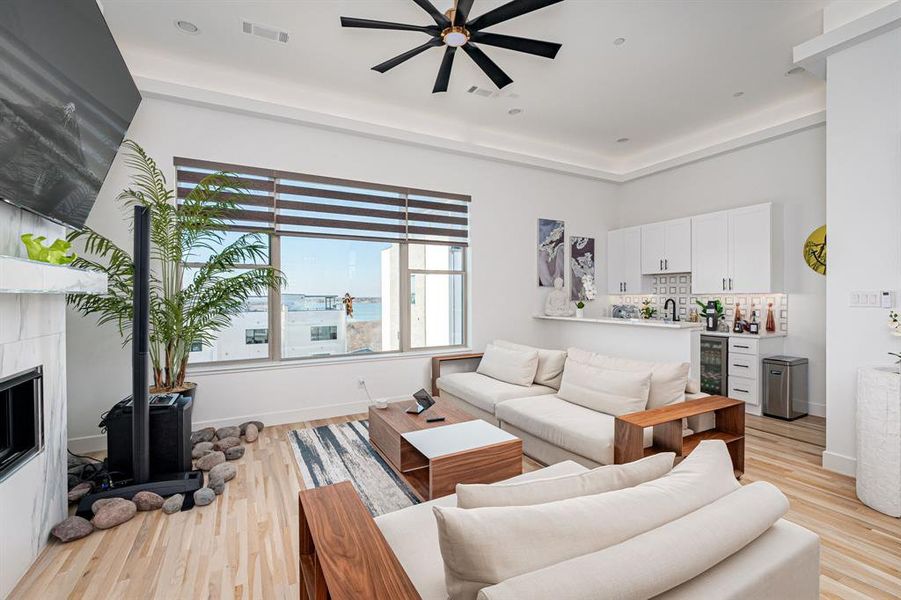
[[619, 126, 835, 415]]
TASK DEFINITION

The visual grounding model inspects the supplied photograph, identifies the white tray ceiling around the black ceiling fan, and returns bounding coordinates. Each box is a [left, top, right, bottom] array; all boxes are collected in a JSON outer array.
[[102, 0, 827, 172]]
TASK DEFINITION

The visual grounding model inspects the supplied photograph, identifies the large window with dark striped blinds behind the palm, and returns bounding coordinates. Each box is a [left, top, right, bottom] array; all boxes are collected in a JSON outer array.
[[176, 159, 469, 362]]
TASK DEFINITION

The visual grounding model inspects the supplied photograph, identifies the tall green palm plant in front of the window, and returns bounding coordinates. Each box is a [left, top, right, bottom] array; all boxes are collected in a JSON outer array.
[[66, 140, 285, 391]]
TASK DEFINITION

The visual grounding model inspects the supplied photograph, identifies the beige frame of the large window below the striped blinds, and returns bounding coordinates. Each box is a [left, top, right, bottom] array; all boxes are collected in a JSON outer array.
[[183, 230, 470, 368]]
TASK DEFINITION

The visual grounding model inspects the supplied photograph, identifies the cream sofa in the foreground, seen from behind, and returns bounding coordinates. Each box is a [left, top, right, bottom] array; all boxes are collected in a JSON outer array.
[[375, 442, 819, 600]]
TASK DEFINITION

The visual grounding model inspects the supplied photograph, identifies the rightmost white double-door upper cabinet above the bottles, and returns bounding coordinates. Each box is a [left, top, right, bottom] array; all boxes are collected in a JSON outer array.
[[691, 204, 782, 294]]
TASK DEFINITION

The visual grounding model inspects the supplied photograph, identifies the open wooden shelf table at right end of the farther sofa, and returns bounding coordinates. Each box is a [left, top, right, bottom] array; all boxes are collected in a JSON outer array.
[[613, 396, 745, 478]]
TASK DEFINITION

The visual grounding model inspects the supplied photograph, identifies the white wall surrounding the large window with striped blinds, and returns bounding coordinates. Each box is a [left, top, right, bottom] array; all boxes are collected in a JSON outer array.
[[68, 99, 617, 449]]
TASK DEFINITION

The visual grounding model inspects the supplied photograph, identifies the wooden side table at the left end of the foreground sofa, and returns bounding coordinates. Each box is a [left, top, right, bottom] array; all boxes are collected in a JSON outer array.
[[299, 481, 420, 600]]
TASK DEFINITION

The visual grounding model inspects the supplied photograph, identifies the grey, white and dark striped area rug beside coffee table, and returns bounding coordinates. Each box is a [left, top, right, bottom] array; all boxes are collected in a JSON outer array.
[[288, 420, 420, 517]]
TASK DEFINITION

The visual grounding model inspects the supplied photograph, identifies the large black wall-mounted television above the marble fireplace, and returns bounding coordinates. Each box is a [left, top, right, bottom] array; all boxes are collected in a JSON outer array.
[[0, 0, 141, 228]]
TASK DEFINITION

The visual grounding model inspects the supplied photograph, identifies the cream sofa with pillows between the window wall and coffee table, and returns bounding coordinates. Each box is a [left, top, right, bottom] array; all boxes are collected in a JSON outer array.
[[436, 340, 713, 468]]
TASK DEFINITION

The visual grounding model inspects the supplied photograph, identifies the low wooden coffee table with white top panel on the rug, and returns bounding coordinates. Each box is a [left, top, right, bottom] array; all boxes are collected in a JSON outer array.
[[369, 398, 522, 500]]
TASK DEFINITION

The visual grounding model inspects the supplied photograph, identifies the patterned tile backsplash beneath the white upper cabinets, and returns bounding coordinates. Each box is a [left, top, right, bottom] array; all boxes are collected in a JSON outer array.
[[610, 273, 788, 333]]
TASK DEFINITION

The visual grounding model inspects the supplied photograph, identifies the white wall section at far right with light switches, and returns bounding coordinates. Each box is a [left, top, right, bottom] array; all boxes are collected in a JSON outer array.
[[824, 29, 901, 475]]
